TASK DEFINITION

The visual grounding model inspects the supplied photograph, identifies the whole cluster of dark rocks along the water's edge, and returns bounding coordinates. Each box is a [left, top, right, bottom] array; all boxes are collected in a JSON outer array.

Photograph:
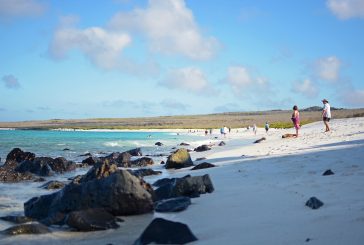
[[0, 142, 214, 244]]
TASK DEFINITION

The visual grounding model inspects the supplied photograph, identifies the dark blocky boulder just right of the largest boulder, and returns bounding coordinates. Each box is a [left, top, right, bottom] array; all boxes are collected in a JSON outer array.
[[155, 174, 214, 200]]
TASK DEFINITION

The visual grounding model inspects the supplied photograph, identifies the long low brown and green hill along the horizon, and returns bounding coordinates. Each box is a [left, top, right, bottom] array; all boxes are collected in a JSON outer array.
[[0, 106, 364, 130]]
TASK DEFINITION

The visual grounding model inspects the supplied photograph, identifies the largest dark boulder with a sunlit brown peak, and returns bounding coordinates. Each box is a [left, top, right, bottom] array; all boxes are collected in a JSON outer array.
[[24, 168, 153, 220]]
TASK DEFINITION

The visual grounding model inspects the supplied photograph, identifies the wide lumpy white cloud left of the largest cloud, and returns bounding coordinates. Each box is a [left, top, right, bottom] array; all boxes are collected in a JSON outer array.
[[49, 17, 131, 69]]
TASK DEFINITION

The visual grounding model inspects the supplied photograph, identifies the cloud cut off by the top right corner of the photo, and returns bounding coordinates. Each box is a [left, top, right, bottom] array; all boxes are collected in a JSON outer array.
[[326, 0, 364, 20]]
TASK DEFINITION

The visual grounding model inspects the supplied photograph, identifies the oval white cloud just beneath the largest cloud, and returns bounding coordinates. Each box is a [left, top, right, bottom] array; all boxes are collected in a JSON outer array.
[[159, 67, 210, 93]]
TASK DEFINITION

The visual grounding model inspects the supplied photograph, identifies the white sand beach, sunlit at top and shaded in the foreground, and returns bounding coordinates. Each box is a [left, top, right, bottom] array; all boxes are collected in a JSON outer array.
[[4, 118, 364, 245]]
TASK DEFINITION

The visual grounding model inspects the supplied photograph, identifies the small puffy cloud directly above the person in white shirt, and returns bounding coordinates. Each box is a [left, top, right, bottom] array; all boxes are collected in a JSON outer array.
[[314, 56, 341, 82]]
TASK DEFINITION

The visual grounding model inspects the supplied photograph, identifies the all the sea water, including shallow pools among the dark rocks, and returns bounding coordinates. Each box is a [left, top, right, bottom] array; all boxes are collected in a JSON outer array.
[[0, 130, 214, 240]]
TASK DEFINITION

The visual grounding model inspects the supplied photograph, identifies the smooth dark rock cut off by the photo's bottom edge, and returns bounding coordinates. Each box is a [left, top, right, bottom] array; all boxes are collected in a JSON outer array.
[[134, 218, 197, 245]]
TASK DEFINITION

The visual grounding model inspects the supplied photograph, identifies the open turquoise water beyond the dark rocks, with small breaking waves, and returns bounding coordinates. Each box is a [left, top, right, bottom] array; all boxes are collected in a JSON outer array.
[[0, 130, 203, 163]]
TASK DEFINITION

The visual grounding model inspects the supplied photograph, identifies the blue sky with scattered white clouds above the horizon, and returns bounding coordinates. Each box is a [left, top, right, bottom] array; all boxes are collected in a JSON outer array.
[[0, 0, 364, 121]]
